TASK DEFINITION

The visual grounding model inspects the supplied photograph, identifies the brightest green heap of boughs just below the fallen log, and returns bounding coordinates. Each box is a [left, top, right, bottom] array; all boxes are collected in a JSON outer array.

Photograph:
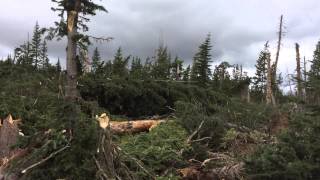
[[120, 122, 190, 179]]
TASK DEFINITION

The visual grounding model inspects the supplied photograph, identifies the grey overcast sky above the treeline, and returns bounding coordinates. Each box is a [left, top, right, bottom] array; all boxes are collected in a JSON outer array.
[[0, 0, 320, 78]]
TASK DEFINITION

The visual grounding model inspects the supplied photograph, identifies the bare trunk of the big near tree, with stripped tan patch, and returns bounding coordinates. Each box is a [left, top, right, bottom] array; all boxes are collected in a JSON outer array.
[[65, 0, 81, 100]]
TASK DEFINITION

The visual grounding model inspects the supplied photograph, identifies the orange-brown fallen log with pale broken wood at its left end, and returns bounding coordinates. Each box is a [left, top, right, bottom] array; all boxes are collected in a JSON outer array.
[[96, 113, 165, 134]]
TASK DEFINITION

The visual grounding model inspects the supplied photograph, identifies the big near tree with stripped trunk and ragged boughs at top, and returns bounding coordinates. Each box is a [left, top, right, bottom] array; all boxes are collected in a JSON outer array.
[[49, 0, 106, 101]]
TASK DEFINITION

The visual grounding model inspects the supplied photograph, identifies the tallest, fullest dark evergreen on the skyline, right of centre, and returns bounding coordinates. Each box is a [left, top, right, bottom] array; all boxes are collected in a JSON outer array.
[[191, 34, 212, 85]]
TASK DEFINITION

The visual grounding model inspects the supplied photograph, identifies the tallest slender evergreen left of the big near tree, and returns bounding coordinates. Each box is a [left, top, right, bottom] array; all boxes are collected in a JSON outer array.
[[31, 22, 42, 69]]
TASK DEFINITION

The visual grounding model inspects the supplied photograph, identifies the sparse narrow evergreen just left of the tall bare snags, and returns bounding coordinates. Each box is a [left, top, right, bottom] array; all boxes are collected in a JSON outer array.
[[253, 44, 270, 94]]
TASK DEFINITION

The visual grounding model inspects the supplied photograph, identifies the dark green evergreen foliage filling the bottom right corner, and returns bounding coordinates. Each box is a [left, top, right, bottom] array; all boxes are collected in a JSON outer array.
[[246, 109, 320, 179]]
